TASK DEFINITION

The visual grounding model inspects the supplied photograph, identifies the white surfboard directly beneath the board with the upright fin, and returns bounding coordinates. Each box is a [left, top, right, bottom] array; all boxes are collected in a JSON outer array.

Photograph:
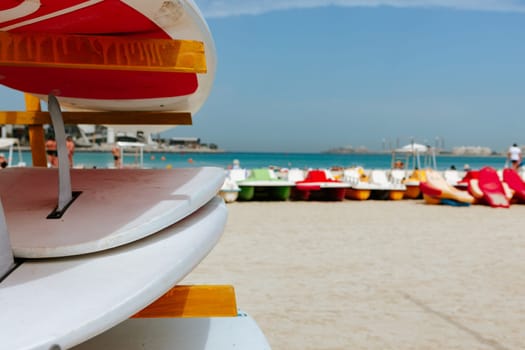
[[0, 197, 227, 350]]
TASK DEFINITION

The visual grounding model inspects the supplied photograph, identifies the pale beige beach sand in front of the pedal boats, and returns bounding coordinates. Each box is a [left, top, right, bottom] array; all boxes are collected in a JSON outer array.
[[183, 200, 525, 350]]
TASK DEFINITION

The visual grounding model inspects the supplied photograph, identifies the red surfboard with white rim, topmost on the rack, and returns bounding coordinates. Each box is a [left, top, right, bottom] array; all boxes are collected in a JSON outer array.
[[0, 0, 216, 113]]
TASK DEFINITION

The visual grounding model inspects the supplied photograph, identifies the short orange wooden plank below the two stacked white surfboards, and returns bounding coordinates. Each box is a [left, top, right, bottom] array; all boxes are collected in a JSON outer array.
[[132, 285, 237, 318]]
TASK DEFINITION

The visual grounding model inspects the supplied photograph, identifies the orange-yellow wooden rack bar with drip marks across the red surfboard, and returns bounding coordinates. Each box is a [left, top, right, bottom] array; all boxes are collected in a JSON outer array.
[[0, 32, 207, 73]]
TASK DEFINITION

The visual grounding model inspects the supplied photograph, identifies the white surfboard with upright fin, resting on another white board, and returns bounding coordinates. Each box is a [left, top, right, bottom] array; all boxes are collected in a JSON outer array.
[[0, 168, 224, 258]]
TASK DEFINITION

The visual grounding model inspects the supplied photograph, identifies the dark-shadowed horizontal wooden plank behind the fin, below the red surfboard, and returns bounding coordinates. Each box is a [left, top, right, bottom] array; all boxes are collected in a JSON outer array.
[[0, 110, 192, 125]]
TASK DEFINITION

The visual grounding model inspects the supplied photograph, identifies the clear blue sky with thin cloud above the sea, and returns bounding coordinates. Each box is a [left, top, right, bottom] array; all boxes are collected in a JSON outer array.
[[0, 0, 525, 152]]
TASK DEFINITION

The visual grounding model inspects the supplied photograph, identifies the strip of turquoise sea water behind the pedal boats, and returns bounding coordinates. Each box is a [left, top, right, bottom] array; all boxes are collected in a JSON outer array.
[[19, 152, 505, 170]]
